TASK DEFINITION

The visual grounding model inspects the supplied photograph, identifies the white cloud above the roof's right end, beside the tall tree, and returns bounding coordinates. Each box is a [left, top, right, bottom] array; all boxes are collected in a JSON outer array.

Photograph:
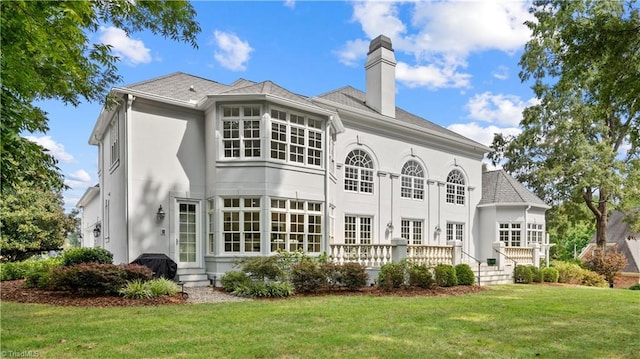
[[465, 92, 537, 126]]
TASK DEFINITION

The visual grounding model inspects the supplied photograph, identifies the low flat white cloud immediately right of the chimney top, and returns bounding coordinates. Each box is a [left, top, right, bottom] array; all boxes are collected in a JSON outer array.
[[396, 62, 471, 89]]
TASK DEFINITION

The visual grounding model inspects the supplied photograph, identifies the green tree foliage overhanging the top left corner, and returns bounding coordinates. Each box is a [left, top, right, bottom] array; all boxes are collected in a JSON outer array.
[[0, 0, 200, 190]]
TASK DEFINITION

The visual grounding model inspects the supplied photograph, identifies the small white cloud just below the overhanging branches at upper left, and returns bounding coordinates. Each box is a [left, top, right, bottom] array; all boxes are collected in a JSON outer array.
[[100, 26, 151, 65]]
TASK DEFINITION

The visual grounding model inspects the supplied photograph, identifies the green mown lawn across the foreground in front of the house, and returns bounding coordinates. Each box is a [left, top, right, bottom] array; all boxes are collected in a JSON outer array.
[[0, 285, 640, 358]]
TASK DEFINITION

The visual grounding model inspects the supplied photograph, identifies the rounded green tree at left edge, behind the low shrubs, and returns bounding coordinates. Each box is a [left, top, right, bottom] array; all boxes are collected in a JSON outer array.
[[0, 185, 73, 261]]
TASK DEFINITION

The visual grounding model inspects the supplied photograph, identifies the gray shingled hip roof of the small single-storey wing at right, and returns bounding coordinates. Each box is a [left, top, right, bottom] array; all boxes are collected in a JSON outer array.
[[478, 170, 548, 207]]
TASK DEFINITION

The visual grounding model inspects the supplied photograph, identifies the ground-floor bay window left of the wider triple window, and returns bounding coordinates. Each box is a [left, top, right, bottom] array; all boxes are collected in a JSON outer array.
[[222, 197, 260, 253]]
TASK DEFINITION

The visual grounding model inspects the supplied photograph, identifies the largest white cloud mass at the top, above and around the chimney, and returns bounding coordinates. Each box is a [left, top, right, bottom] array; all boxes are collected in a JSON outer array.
[[336, 1, 532, 89]]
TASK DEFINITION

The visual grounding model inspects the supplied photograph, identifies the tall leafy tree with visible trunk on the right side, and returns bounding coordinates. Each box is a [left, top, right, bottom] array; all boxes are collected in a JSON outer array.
[[490, 0, 640, 247]]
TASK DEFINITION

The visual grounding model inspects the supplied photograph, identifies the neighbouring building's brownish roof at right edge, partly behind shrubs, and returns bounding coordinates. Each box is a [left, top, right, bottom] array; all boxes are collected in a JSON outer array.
[[589, 211, 640, 273]]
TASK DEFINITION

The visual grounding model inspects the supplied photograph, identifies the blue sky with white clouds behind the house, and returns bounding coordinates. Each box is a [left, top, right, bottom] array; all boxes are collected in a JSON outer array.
[[31, 1, 534, 209]]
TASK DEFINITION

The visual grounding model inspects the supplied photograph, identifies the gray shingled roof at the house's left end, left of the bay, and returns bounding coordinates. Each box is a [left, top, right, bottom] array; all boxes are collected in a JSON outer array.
[[124, 72, 231, 102]]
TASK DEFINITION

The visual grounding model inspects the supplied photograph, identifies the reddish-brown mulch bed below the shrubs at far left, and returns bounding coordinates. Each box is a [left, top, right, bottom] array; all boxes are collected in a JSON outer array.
[[0, 280, 186, 307]]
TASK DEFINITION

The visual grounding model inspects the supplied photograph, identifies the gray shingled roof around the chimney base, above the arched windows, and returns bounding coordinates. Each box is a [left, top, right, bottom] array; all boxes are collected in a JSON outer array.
[[317, 86, 484, 147]]
